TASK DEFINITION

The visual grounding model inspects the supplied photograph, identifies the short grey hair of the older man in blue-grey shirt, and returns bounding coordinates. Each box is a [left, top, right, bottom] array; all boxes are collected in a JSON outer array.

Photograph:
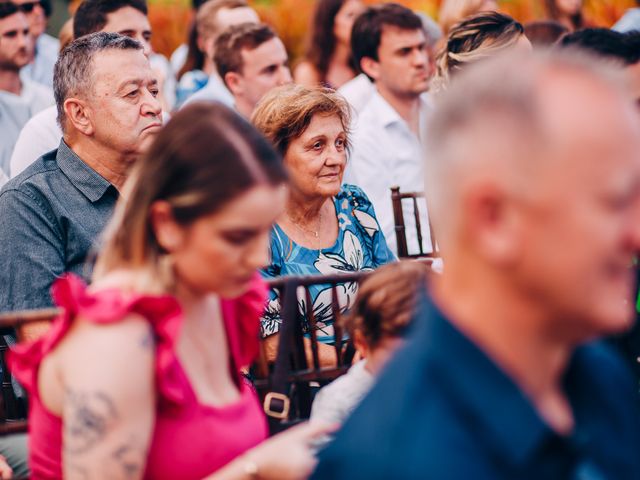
[[53, 32, 143, 131]]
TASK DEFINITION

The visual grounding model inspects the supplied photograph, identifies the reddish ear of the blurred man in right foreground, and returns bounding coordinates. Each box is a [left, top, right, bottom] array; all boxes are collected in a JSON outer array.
[[462, 185, 526, 265]]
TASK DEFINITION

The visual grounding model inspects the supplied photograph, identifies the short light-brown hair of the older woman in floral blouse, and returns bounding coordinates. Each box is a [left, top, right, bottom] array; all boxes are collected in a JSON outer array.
[[251, 84, 351, 156]]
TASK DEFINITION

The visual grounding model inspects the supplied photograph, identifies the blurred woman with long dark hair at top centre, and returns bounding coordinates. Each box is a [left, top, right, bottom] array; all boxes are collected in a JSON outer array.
[[294, 0, 364, 89]]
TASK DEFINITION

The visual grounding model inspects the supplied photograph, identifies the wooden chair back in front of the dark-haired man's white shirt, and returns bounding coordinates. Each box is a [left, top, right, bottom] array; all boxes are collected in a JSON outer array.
[[391, 187, 438, 258]]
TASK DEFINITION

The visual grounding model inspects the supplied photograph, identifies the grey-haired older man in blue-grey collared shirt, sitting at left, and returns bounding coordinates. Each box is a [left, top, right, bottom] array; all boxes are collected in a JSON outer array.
[[0, 32, 162, 311]]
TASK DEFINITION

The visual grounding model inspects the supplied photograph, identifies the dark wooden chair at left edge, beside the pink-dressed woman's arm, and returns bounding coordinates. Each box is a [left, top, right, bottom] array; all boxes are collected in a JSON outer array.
[[0, 308, 60, 436]]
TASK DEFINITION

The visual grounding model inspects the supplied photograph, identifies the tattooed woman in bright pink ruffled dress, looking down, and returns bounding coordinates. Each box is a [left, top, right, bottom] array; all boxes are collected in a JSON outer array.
[[10, 104, 327, 480]]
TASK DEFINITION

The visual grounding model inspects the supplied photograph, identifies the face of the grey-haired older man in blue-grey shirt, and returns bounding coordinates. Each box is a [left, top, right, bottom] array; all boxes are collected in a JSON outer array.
[[84, 50, 162, 159]]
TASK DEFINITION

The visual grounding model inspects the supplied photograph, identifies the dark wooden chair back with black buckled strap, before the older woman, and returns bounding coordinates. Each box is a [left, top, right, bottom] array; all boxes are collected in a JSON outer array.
[[252, 272, 368, 434]]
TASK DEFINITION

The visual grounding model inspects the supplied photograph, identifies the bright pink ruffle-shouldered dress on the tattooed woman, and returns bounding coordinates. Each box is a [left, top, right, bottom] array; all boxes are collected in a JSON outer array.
[[9, 275, 267, 480]]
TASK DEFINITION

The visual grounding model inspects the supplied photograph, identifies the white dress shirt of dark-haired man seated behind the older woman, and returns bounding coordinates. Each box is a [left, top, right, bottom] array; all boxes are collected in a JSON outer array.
[[344, 91, 433, 255]]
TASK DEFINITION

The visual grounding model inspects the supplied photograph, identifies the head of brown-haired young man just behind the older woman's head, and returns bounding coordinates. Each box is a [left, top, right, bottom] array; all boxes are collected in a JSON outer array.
[[214, 23, 291, 118]]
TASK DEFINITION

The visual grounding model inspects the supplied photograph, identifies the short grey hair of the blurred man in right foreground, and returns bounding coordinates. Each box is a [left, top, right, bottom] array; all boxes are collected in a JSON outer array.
[[425, 49, 631, 241]]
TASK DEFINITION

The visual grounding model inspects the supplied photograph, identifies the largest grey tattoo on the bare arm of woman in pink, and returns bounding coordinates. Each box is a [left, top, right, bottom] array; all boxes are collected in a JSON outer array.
[[64, 389, 118, 455]]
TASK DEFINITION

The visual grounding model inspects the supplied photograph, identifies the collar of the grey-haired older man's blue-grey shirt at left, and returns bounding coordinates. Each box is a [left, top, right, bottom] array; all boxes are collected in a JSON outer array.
[[56, 140, 116, 203]]
